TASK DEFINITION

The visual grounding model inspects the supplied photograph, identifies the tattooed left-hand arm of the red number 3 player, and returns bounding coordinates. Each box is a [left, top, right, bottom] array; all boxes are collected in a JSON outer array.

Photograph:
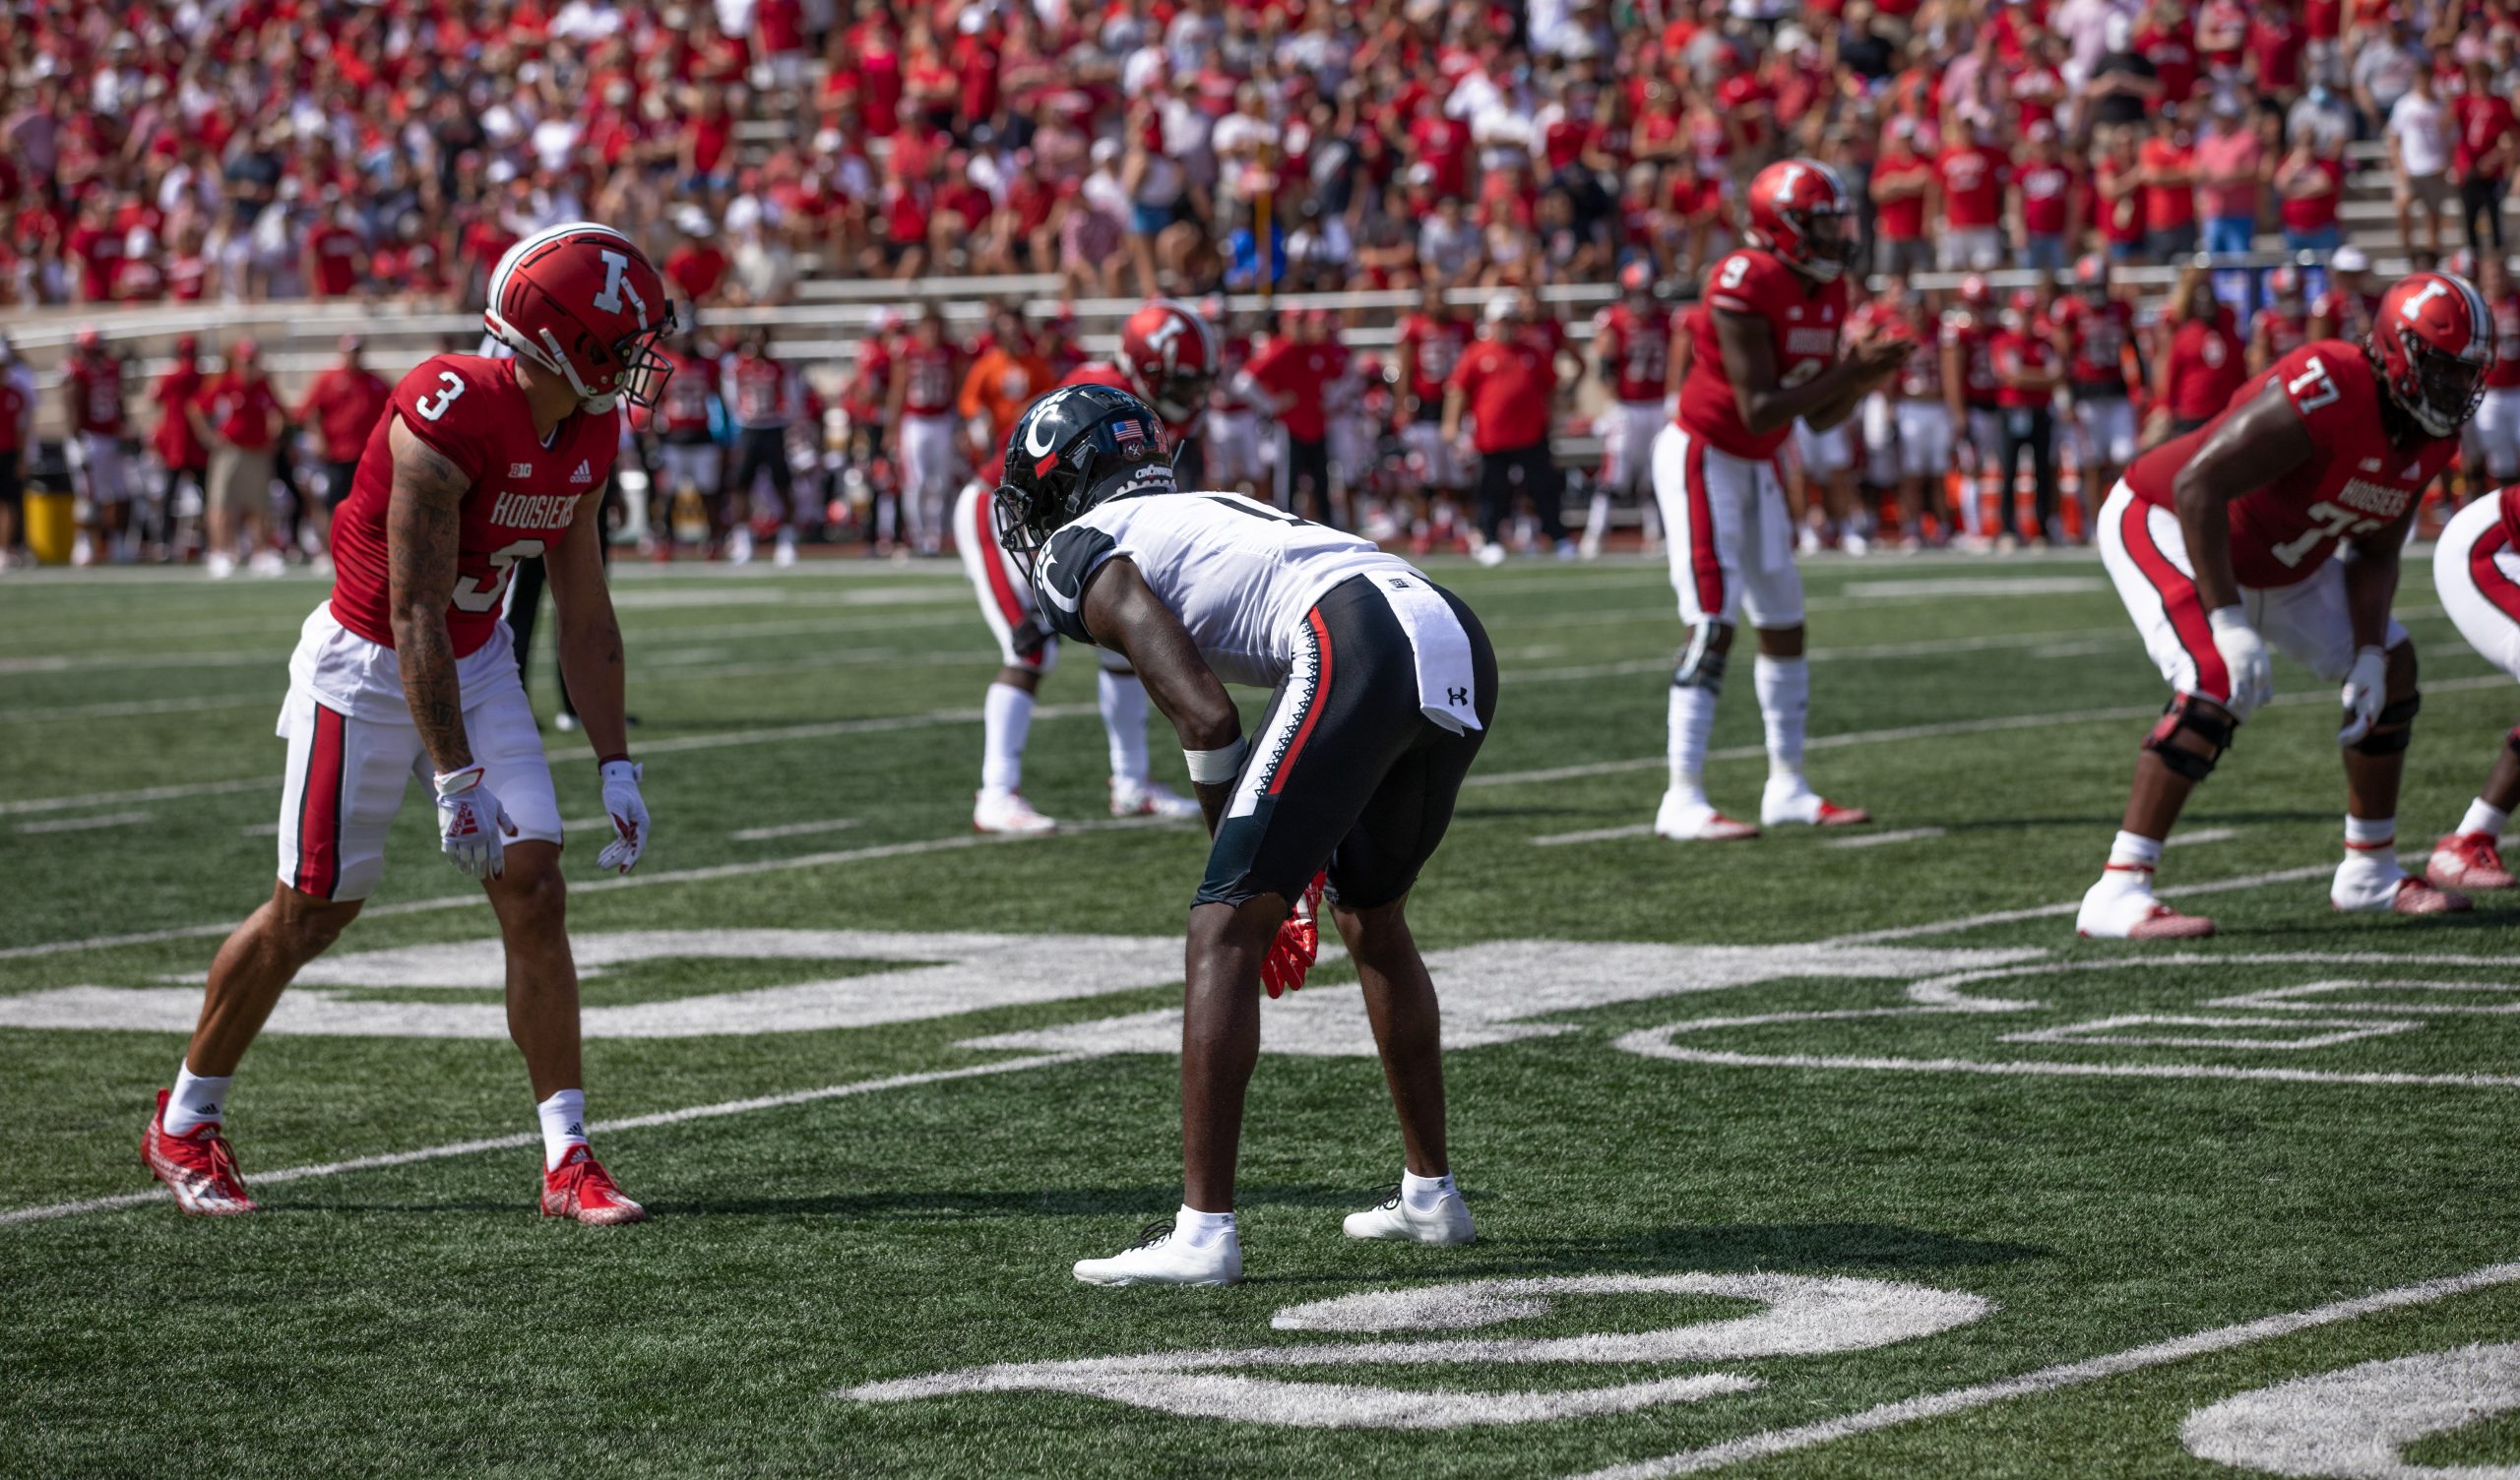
[[386, 409, 472, 772]]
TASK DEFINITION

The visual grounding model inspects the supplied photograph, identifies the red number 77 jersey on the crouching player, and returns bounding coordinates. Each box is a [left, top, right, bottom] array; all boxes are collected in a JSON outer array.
[[2127, 339, 2460, 591]]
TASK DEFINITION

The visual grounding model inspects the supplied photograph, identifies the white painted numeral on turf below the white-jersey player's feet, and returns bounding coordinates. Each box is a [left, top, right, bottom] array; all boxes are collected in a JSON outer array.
[[832, 1273, 1996, 1430]]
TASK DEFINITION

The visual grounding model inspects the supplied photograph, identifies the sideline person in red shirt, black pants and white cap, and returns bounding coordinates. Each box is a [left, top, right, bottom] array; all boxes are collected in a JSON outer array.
[[1444, 289, 1575, 567]]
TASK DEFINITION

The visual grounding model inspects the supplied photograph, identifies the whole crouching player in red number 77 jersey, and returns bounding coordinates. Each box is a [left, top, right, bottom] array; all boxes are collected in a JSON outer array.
[[2076, 272, 2492, 939]]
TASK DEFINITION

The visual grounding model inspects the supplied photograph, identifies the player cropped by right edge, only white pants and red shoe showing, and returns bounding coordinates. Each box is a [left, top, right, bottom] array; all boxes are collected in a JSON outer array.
[[2425, 488, 2520, 889]]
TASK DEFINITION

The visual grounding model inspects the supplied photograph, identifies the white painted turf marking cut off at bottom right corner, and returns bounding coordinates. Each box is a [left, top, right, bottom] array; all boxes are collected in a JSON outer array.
[[2179, 1344, 2520, 1480]]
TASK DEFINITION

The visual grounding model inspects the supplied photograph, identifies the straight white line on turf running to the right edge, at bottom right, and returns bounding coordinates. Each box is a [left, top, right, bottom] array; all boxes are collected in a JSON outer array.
[[1575, 1264, 2520, 1480]]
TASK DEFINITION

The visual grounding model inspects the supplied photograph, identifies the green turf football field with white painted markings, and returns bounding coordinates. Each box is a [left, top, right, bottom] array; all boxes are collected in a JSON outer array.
[[0, 548, 2520, 1477]]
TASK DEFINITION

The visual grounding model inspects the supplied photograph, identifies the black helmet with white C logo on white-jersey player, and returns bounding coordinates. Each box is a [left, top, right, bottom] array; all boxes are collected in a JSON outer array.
[[995, 385, 1174, 572]]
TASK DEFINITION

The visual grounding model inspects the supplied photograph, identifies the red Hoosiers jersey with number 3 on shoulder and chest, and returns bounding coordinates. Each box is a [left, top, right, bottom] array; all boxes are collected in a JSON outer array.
[[333, 355, 620, 657]]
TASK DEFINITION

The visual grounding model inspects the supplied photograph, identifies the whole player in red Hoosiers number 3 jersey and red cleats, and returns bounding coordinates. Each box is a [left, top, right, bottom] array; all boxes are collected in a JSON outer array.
[[141, 221, 673, 1223]]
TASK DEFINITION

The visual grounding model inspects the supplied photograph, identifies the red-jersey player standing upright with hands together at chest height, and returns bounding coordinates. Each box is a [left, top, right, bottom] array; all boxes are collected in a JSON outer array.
[[1653, 158, 1916, 840]]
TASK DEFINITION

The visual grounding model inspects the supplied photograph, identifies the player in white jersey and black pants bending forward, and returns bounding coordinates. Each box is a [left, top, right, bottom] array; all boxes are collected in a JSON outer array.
[[998, 385, 1497, 1283]]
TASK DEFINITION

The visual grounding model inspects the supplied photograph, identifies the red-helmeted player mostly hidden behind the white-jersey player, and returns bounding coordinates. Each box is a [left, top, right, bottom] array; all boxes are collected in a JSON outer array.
[[953, 299, 1217, 833]]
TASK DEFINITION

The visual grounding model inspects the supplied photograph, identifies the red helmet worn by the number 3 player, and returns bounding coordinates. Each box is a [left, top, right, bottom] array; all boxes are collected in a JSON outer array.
[[481, 221, 673, 410]]
